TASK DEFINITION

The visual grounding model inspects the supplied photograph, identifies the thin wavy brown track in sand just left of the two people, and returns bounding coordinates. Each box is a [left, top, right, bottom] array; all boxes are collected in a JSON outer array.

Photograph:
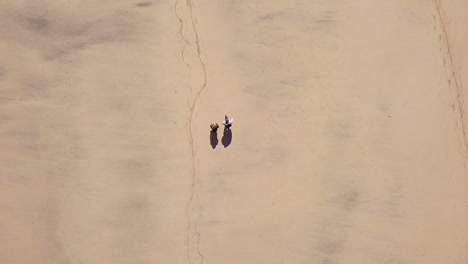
[[174, 0, 207, 263]]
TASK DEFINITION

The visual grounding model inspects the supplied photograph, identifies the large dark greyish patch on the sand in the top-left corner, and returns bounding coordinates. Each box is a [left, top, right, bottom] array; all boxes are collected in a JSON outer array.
[[10, 1, 146, 61]]
